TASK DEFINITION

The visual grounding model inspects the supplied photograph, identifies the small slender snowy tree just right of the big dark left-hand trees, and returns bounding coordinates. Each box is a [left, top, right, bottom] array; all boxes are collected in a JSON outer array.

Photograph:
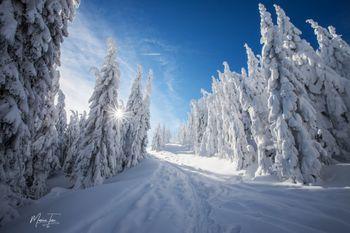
[[56, 90, 67, 164]]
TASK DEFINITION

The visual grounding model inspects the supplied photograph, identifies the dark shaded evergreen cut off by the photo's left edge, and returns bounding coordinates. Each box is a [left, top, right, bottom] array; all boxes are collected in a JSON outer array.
[[0, 0, 31, 222]]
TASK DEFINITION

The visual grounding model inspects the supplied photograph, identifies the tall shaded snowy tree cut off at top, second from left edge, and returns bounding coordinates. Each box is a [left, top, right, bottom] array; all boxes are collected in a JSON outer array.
[[23, 0, 76, 198]]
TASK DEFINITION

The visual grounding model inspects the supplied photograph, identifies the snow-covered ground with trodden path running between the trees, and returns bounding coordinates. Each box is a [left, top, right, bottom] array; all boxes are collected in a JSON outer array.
[[0, 145, 350, 233]]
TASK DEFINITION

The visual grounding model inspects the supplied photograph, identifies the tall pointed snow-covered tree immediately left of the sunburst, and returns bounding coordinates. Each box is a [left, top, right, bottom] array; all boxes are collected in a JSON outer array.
[[75, 39, 122, 188]]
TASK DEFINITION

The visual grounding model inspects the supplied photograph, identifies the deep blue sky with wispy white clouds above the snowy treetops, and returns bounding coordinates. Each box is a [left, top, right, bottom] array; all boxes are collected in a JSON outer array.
[[60, 0, 350, 132]]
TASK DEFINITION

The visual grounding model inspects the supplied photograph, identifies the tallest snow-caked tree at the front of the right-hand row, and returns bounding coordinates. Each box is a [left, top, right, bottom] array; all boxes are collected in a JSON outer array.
[[259, 4, 321, 182]]
